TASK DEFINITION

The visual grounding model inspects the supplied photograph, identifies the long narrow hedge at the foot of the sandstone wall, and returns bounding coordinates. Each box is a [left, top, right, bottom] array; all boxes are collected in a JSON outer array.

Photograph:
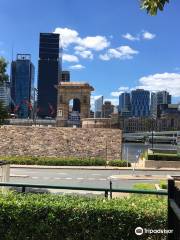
[[0, 156, 131, 167]]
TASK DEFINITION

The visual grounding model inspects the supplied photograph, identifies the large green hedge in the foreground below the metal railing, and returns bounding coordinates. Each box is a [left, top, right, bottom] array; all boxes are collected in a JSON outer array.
[[0, 193, 167, 240]]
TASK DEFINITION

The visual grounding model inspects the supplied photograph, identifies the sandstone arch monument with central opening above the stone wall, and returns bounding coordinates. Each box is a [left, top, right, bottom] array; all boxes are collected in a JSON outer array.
[[57, 82, 94, 127]]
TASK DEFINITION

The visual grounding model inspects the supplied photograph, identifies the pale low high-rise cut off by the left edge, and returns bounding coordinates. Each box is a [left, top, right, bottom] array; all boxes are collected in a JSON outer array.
[[0, 82, 10, 107]]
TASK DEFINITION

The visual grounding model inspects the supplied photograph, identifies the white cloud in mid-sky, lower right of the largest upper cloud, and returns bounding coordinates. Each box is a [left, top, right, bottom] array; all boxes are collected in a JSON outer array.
[[99, 46, 139, 61]]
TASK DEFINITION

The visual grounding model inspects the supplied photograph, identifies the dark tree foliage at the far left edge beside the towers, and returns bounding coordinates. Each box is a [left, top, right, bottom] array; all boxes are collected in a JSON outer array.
[[0, 57, 9, 124]]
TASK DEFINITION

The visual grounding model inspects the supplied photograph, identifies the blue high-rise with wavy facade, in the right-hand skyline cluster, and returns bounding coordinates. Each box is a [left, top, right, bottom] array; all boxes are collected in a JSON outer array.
[[131, 89, 150, 117]]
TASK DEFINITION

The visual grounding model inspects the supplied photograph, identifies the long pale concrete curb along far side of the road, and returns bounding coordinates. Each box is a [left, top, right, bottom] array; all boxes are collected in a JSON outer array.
[[10, 164, 180, 171]]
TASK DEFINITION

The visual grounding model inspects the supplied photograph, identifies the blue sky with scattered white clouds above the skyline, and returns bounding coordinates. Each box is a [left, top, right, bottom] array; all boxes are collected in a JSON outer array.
[[0, 0, 180, 104]]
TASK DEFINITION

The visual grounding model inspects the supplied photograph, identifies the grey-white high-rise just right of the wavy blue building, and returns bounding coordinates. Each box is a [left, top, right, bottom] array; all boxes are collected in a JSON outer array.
[[150, 91, 171, 118]]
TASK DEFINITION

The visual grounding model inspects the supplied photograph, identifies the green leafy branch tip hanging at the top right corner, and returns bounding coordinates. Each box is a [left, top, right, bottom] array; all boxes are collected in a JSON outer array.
[[141, 0, 169, 16]]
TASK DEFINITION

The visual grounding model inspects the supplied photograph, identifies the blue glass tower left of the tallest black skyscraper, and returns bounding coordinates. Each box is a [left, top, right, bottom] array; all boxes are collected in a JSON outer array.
[[11, 54, 34, 118]]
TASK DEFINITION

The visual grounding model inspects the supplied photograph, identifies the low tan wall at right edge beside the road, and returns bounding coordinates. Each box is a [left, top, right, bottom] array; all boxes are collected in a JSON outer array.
[[144, 160, 180, 168]]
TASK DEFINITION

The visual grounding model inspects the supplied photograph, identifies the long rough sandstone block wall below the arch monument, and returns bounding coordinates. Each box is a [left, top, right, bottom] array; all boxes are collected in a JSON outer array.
[[0, 126, 122, 159]]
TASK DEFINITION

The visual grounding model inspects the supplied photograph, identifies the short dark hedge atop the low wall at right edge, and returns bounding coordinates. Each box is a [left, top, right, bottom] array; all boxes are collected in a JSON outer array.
[[148, 153, 180, 161]]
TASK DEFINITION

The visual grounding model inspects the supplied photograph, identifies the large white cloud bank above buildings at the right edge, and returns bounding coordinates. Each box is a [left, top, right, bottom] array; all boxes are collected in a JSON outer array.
[[137, 72, 180, 97]]
